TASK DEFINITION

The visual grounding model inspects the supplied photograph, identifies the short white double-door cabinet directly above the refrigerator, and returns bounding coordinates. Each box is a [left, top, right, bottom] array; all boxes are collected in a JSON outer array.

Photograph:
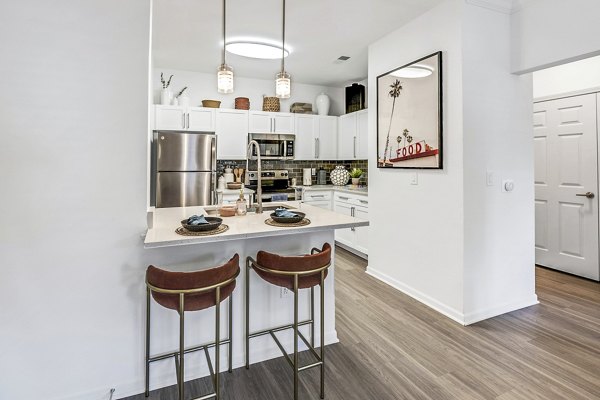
[[154, 105, 215, 132]]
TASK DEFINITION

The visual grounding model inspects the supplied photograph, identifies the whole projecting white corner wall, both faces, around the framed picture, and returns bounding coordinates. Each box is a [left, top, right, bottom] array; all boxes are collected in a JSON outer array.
[[368, 0, 537, 324]]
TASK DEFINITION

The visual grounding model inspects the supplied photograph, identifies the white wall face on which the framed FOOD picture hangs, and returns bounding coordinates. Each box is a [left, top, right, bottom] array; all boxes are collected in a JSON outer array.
[[368, 0, 464, 322]]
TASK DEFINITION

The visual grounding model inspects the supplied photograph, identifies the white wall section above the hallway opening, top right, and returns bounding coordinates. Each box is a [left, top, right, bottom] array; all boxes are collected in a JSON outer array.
[[512, 0, 600, 73]]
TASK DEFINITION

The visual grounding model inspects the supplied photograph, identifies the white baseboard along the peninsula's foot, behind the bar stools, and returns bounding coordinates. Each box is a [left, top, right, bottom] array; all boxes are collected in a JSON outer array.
[[54, 330, 340, 400]]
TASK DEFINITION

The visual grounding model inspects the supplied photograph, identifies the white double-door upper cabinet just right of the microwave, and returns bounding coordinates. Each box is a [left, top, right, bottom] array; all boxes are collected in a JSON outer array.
[[294, 114, 338, 160]]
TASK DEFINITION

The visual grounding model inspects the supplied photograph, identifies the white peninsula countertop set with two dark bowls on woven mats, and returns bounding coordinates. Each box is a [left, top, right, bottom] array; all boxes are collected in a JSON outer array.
[[144, 201, 369, 248]]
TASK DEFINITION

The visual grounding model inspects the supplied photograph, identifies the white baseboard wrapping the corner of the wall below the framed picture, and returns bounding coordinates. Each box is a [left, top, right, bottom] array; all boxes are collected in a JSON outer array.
[[367, 267, 539, 326]]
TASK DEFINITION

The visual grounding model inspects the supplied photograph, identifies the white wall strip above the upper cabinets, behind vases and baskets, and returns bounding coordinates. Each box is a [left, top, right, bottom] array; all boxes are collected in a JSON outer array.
[[152, 68, 346, 115]]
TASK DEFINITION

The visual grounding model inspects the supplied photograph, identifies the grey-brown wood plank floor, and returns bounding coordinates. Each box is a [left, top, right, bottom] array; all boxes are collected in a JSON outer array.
[[127, 249, 600, 400]]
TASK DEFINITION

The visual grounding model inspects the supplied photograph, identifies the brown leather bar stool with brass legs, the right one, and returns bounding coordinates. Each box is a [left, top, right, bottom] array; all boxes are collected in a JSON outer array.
[[246, 243, 331, 400]]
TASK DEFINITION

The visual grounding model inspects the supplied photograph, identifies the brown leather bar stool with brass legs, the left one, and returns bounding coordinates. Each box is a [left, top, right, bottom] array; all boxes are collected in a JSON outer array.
[[145, 254, 240, 400]]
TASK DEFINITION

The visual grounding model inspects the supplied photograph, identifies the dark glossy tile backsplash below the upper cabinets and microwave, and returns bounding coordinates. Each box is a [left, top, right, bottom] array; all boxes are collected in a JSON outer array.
[[217, 160, 369, 185]]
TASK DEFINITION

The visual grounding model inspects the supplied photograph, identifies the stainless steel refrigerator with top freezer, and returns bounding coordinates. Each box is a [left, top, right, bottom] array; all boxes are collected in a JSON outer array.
[[153, 131, 217, 208]]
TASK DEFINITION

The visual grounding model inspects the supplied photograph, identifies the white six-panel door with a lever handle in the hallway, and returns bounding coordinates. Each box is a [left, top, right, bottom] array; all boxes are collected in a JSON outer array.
[[533, 94, 600, 280]]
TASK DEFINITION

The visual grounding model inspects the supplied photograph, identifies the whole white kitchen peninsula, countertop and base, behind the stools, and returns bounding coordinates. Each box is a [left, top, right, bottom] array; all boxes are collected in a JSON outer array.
[[144, 201, 369, 386]]
